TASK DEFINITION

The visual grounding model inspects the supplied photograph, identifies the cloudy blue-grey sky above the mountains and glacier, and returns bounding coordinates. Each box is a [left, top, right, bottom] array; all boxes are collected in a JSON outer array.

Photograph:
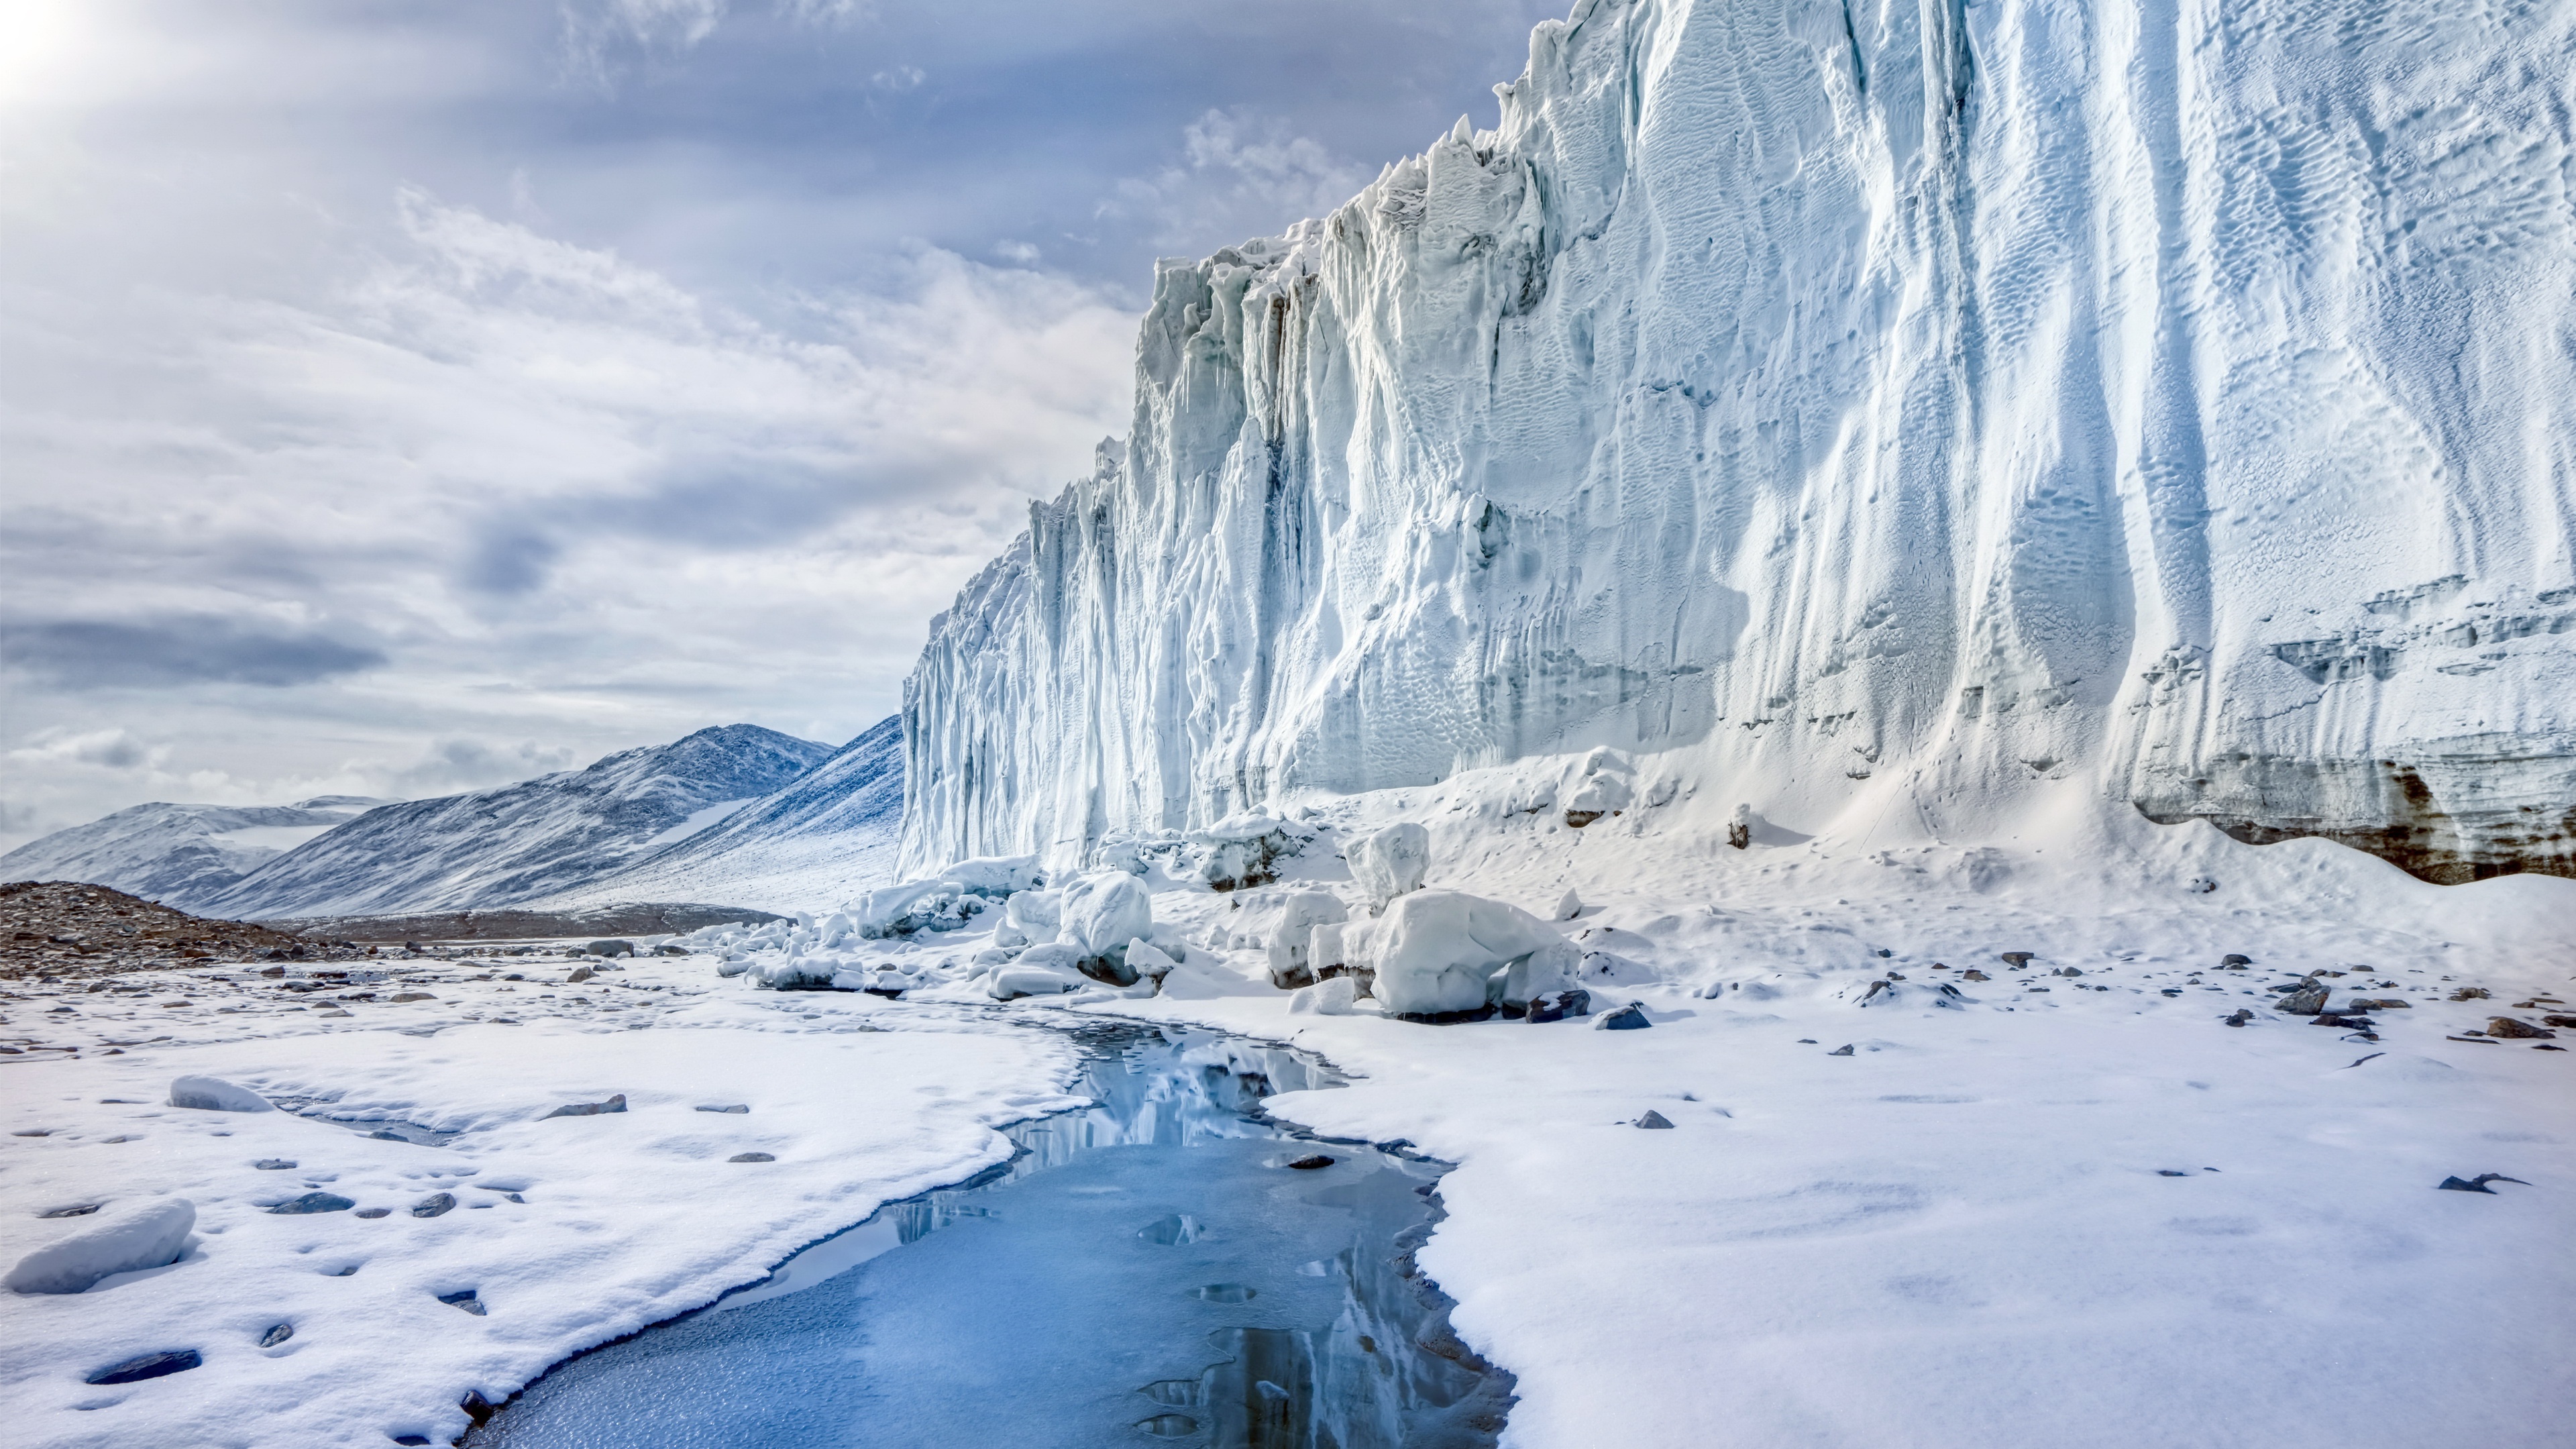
[[0, 0, 1561, 848]]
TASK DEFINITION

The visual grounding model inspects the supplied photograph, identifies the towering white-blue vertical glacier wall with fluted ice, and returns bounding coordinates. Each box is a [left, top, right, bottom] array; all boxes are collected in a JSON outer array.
[[902, 0, 2576, 879]]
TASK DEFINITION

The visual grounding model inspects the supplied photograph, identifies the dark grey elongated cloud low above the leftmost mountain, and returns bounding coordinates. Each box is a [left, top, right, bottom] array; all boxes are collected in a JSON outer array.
[[0, 616, 386, 688]]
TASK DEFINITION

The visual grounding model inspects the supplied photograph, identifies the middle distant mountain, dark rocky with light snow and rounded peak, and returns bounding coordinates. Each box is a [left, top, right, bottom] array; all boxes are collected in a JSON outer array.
[[201, 724, 832, 920]]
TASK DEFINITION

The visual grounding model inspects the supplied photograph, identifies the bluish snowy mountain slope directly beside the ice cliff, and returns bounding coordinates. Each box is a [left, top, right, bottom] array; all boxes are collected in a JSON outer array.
[[541, 716, 904, 910]]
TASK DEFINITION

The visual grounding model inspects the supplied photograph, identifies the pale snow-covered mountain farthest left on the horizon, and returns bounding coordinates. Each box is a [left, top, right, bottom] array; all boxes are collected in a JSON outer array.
[[0, 794, 392, 910]]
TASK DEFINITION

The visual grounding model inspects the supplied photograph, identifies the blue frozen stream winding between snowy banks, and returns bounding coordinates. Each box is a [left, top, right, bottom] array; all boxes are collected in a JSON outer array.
[[466, 1024, 1512, 1449]]
